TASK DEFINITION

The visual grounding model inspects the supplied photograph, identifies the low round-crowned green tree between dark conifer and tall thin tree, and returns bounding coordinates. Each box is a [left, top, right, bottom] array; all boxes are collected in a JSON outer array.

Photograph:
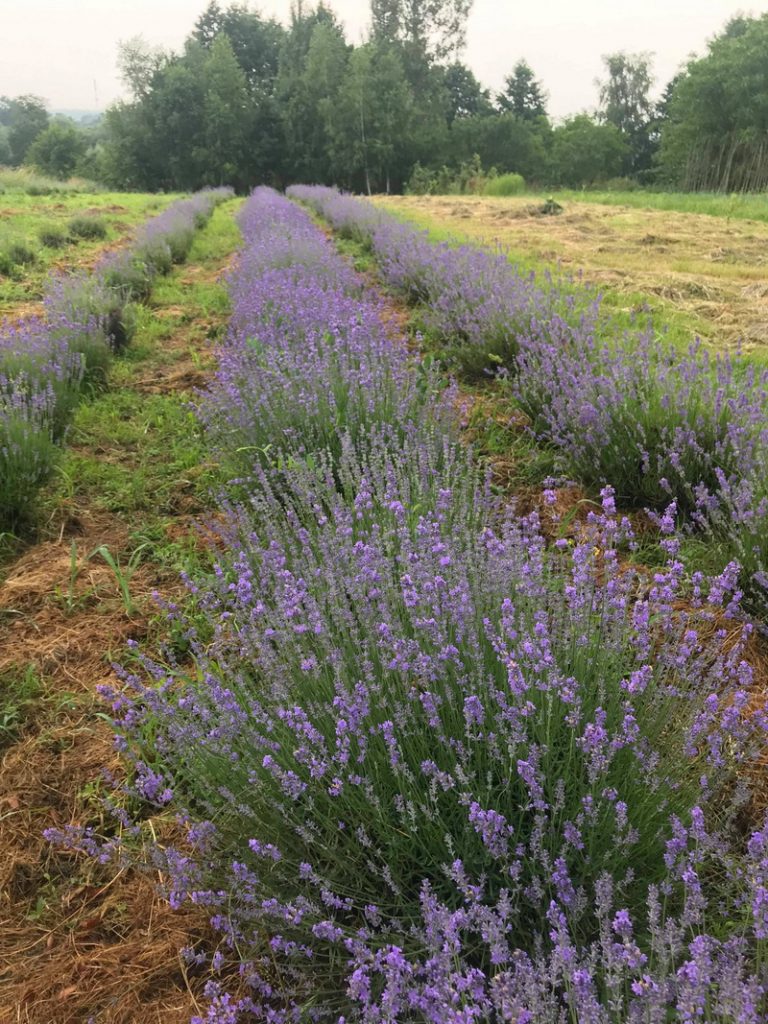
[[552, 114, 629, 186]]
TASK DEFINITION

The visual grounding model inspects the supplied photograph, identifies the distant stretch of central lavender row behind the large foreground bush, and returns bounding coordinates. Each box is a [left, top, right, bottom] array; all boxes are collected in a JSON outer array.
[[199, 189, 453, 474]]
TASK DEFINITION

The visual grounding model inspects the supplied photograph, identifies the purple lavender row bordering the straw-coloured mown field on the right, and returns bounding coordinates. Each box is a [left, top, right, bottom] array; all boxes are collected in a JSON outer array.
[[291, 186, 768, 610]]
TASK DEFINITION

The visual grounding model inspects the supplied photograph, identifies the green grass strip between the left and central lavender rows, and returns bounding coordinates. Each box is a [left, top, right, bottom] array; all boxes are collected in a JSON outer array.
[[43, 197, 240, 536]]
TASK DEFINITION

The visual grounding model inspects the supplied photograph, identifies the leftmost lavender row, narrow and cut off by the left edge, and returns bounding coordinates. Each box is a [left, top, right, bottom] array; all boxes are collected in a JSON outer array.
[[0, 188, 231, 528]]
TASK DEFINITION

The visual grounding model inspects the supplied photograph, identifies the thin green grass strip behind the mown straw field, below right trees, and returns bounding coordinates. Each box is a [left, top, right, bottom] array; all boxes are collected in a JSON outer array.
[[550, 189, 768, 222]]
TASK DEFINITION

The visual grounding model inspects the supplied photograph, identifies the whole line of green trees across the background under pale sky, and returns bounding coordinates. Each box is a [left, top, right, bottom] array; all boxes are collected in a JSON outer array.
[[0, 0, 768, 193]]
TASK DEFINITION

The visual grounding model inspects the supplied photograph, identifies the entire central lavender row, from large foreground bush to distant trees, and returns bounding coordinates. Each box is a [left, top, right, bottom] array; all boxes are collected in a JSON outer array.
[[57, 189, 768, 1024]]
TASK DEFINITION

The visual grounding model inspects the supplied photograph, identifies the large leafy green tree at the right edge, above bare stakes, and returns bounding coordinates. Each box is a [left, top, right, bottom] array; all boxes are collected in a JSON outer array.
[[658, 14, 768, 191]]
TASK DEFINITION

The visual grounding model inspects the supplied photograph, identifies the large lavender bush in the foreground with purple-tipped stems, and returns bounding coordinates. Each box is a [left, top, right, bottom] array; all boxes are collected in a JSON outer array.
[[94, 481, 768, 1024]]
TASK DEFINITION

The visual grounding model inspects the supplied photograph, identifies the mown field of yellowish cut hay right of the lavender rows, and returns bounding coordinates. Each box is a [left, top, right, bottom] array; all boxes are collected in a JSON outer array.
[[376, 193, 768, 360]]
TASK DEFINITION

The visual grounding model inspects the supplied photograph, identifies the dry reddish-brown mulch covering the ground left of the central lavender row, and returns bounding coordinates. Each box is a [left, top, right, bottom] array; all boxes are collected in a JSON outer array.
[[0, 245, 234, 1024]]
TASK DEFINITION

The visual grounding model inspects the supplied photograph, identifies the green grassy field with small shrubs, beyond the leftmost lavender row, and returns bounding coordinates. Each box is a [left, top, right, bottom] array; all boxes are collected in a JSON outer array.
[[0, 190, 178, 317]]
